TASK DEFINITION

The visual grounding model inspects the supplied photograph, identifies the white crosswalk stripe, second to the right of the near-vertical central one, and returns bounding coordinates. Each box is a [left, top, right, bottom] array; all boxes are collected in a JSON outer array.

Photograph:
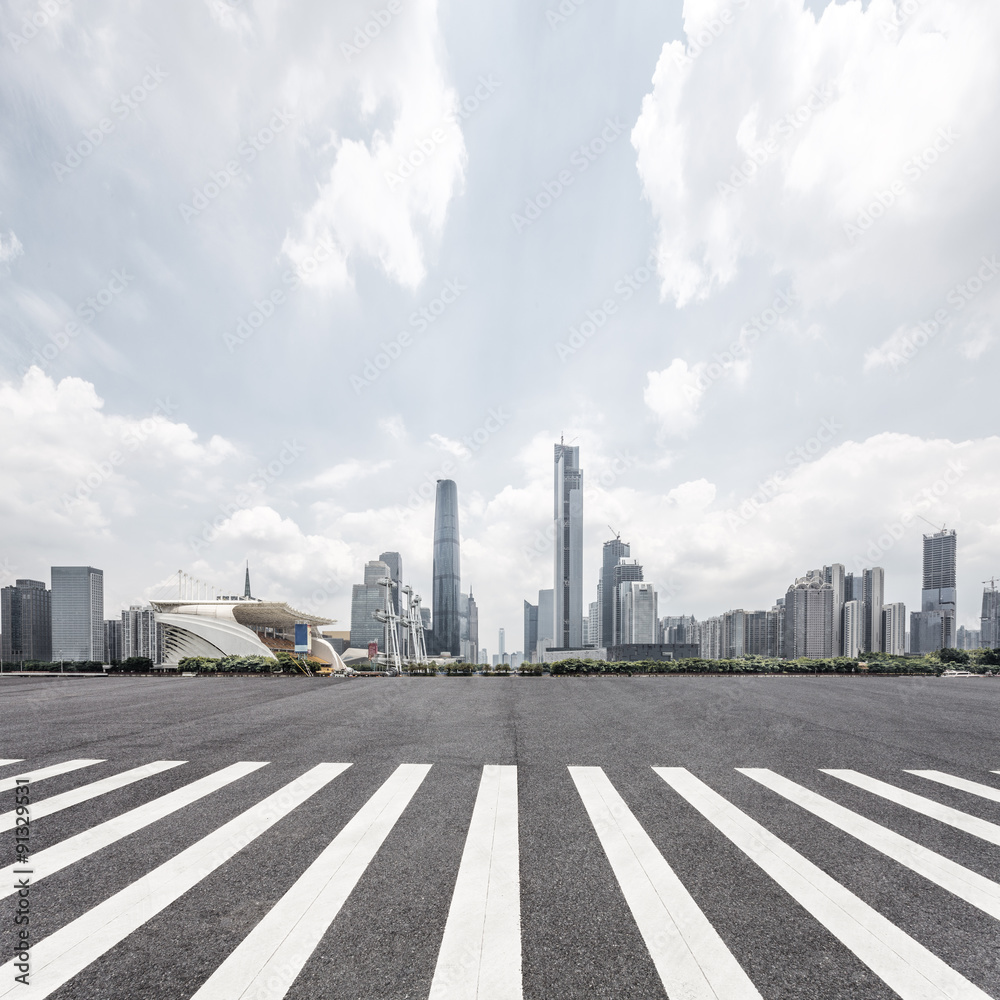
[[653, 767, 990, 1000]]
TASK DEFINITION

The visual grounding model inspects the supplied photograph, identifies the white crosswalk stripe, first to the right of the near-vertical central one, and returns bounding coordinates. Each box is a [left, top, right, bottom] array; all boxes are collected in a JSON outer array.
[[569, 767, 760, 1000]]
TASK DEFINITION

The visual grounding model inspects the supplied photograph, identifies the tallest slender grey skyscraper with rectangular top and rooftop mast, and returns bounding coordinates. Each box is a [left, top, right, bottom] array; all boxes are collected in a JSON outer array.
[[552, 441, 583, 649]]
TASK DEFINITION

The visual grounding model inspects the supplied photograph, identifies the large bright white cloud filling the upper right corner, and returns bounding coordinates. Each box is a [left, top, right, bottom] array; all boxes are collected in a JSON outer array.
[[632, 0, 1000, 305]]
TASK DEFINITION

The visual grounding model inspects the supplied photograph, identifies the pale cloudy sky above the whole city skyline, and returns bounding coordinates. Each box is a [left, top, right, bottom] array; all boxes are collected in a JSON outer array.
[[0, 0, 1000, 652]]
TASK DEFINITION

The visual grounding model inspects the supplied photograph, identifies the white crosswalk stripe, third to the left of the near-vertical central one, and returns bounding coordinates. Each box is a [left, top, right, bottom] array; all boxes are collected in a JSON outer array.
[[0, 760, 267, 899]]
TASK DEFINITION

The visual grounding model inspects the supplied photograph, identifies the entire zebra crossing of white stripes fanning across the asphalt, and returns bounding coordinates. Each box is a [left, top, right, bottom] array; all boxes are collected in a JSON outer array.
[[0, 759, 1000, 1000]]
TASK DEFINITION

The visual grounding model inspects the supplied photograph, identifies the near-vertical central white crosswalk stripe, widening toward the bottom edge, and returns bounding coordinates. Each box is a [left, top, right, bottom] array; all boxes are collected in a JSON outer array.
[[430, 765, 523, 1000]]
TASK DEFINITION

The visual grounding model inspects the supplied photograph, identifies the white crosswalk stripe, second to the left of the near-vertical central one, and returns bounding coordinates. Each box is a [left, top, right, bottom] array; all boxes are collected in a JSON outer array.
[[0, 764, 350, 1000]]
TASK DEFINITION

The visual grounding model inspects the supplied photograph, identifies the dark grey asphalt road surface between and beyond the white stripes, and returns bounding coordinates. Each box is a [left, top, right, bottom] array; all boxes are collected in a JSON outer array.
[[0, 677, 1000, 1000]]
